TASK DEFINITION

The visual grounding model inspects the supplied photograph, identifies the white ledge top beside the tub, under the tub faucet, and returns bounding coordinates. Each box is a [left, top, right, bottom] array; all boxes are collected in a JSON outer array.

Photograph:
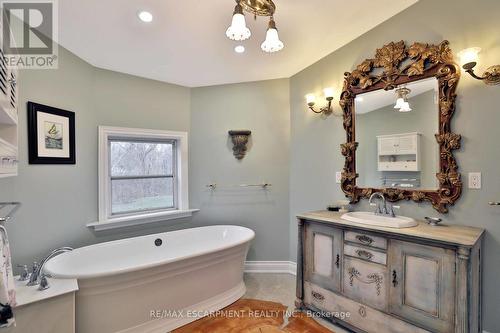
[[14, 276, 78, 307]]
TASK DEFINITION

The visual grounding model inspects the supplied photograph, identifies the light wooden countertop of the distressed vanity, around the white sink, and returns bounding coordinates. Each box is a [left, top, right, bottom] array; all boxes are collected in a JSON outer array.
[[297, 210, 484, 247]]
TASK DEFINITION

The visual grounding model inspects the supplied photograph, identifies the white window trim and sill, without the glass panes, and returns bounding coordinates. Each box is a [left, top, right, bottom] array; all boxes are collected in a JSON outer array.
[[87, 126, 197, 230]]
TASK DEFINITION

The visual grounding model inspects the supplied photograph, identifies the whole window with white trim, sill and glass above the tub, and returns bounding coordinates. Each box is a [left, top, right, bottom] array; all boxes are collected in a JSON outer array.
[[93, 126, 194, 229]]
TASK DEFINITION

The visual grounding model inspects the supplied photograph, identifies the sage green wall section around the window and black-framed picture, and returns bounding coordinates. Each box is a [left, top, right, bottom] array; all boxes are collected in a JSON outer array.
[[0, 44, 191, 264]]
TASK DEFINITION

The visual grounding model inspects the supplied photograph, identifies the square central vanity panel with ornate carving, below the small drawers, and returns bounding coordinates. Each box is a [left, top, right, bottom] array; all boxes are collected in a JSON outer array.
[[343, 257, 389, 311]]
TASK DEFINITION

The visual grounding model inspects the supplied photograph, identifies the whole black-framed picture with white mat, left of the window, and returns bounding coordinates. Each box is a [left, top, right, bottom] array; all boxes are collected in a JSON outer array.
[[28, 102, 76, 164]]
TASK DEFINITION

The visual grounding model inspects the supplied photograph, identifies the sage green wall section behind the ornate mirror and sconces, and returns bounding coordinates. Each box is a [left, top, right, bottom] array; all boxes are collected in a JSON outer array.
[[290, 0, 500, 333]]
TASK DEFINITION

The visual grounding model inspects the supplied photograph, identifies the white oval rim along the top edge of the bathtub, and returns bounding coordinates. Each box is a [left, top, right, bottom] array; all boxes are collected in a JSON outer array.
[[44, 224, 255, 280]]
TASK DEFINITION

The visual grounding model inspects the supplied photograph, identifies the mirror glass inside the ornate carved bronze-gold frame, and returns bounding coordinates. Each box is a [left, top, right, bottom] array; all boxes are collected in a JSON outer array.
[[355, 77, 439, 190]]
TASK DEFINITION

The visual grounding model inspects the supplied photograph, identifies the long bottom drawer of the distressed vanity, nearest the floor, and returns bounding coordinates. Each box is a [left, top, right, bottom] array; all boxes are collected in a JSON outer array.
[[304, 282, 430, 333]]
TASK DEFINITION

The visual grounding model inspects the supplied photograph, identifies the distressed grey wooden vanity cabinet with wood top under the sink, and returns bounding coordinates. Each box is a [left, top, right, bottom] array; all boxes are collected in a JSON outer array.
[[296, 211, 484, 333]]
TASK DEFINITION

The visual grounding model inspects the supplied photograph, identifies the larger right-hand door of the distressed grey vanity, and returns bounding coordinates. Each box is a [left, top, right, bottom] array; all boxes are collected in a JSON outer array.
[[389, 240, 456, 333]]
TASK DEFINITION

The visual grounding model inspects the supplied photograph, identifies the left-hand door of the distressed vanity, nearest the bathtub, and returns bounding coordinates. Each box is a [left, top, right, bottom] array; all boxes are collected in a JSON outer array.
[[304, 223, 342, 291]]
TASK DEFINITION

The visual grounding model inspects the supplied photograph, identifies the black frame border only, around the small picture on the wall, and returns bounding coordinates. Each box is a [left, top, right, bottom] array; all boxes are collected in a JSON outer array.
[[28, 102, 76, 164]]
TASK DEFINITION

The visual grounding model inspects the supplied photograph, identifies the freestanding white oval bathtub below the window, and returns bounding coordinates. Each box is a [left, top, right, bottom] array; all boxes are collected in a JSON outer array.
[[45, 226, 255, 333]]
